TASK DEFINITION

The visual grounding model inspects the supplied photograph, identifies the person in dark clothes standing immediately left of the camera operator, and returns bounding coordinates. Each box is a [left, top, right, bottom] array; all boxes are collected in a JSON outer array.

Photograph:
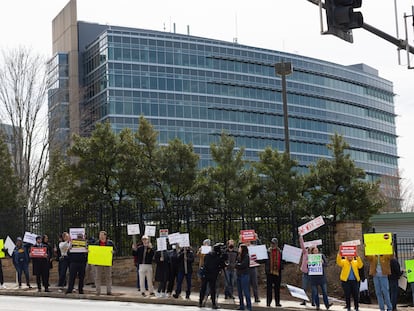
[[173, 247, 194, 299]]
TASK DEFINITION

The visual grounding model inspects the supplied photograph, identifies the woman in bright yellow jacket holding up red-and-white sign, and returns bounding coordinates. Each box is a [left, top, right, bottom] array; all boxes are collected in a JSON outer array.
[[336, 253, 364, 311]]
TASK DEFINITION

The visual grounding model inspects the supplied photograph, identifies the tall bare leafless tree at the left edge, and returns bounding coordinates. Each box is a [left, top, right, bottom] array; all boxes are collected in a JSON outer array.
[[0, 47, 49, 222]]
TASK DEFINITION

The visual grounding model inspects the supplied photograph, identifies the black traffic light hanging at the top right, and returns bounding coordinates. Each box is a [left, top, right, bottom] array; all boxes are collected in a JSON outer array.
[[325, 0, 364, 42]]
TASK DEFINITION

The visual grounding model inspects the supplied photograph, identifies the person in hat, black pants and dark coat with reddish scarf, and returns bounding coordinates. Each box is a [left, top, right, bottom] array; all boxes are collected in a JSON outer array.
[[265, 238, 282, 307]]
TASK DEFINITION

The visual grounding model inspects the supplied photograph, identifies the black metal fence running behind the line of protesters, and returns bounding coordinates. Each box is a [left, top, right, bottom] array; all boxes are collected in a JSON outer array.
[[0, 204, 335, 256]]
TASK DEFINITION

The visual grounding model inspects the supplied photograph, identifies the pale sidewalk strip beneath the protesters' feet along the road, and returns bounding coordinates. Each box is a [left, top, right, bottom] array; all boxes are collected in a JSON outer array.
[[0, 283, 394, 311]]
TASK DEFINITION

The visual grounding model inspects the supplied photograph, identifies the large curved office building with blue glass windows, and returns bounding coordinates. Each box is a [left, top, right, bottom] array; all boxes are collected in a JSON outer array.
[[50, 0, 398, 184]]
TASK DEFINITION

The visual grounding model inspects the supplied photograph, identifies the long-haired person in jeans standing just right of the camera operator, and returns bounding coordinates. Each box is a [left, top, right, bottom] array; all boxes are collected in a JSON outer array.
[[236, 244, 252, 311]]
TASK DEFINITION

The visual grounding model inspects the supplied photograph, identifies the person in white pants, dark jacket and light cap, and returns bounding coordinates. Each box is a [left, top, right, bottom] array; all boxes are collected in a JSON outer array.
[[136, 235, 154, 297]]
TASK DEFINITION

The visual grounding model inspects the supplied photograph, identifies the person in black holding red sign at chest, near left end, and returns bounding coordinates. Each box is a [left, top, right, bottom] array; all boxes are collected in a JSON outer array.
[[31, 235, 50, 292]]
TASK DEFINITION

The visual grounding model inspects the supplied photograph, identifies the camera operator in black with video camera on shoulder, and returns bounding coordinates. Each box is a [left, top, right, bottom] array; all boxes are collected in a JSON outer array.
[[198, 243, 227, 309]]
